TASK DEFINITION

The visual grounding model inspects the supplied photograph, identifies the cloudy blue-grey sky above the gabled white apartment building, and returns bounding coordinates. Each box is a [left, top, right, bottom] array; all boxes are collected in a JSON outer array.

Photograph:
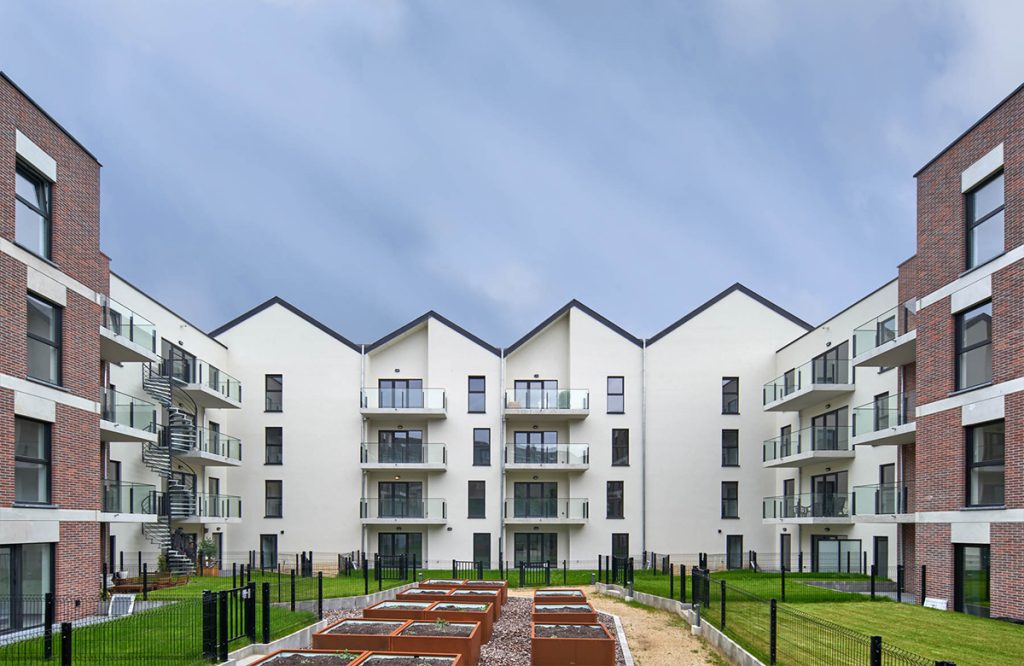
[[0, 0, 1024, 345]]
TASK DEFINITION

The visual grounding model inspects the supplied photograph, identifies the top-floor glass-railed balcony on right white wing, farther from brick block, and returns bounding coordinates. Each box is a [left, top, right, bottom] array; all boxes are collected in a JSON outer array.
[[761, 359, 854, 412]]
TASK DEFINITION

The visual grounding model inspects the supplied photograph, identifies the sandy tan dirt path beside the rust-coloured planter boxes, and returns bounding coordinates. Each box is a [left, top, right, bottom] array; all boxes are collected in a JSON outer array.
[[509, 587, 728, 666]]
